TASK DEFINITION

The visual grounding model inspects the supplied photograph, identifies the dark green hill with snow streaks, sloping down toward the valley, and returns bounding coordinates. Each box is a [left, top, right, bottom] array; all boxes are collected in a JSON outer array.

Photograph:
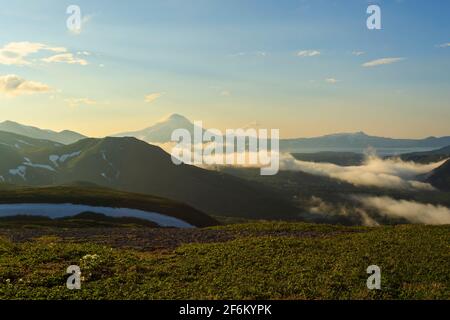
[[0, 132, 298, 219]]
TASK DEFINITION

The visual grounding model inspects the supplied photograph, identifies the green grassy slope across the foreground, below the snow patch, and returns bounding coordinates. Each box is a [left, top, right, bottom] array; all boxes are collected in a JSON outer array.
[[0, 223, 450, 299]]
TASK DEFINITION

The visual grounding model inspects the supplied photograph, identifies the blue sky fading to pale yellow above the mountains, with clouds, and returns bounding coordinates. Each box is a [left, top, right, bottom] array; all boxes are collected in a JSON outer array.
[[0, 0, 450, 138]]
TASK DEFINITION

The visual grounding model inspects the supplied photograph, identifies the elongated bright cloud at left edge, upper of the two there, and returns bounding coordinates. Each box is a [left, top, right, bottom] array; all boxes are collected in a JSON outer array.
[[0, 41, 67, 66]]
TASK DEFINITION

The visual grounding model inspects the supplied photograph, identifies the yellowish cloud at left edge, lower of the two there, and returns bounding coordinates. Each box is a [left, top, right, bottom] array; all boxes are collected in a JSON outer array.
[[0, 74, 50, 97]]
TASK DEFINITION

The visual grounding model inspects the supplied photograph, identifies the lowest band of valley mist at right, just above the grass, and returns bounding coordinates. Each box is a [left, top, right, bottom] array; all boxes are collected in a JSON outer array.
[[354, 196, 450, 225]]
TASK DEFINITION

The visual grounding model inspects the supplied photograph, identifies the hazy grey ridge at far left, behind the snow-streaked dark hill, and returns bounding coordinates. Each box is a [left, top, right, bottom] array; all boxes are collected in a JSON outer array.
[[0, 121, 86, 144]]
